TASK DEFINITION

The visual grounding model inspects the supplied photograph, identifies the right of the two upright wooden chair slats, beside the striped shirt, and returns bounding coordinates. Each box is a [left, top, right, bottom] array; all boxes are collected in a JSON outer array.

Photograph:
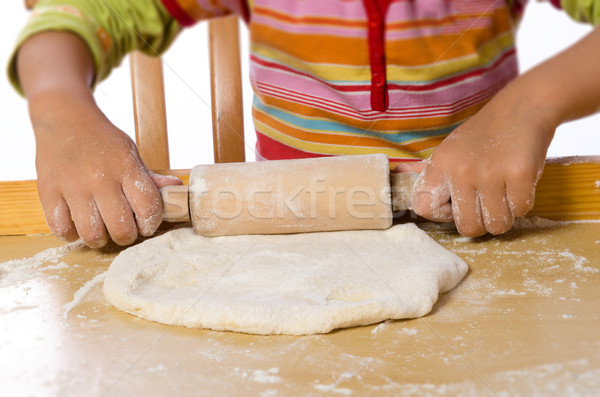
[[208, 17, 245, 163]]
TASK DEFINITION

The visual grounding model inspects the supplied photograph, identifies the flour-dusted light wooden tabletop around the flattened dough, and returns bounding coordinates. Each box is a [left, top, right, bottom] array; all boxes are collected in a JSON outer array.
[[0, 218, 600, 396]]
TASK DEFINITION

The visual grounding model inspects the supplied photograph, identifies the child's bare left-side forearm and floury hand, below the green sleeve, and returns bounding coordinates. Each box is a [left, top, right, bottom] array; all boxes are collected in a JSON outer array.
[[17, 32, 180, 247]]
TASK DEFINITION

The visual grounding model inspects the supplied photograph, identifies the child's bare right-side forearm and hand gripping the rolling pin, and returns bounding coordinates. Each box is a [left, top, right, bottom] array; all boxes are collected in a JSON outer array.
[[414, 28, 600, 236]]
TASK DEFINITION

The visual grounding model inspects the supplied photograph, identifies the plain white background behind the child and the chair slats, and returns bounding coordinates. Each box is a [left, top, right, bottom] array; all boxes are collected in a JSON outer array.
[[0, 0, 600, 180]]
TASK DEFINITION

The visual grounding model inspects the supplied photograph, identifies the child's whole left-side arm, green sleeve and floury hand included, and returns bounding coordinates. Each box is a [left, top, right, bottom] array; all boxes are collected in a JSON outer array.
[[8, 0, 188, 247]]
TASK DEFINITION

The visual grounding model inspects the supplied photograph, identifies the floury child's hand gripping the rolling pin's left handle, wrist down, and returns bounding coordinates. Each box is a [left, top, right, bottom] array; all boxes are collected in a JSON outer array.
[[32, 97, 181, 247]]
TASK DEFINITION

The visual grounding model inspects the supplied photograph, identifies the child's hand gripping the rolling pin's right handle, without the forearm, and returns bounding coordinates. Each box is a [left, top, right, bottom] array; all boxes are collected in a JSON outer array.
[[413, 86, 554, 237]]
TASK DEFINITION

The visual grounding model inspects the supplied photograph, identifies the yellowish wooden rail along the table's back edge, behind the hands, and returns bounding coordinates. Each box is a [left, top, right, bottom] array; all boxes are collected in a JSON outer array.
[[0, 159, 600, 235]]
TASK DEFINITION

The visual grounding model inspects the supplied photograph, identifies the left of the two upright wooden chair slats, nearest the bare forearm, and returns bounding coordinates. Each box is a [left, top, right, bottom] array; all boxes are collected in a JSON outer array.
[[129, 51, 170, 169]]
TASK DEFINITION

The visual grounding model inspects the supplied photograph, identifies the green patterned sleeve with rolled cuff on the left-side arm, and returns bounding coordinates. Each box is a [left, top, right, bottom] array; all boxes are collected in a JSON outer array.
[[8, 0, 182, 94]]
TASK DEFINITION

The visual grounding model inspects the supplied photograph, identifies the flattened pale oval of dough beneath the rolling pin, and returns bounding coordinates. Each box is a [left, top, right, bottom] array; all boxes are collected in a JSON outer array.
[[104, 224, 468, 335]]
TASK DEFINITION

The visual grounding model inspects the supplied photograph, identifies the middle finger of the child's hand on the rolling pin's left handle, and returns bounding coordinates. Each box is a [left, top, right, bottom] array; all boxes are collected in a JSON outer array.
[[96, 185, 138, 245]]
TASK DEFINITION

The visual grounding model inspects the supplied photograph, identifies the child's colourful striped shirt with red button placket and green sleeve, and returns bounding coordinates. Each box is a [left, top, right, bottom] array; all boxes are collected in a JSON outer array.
[[12, 0, 600, 161]]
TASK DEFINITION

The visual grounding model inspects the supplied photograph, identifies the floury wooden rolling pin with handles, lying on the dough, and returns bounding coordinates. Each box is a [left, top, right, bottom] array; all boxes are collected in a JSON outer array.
[[161, 154, 417, 237]]
